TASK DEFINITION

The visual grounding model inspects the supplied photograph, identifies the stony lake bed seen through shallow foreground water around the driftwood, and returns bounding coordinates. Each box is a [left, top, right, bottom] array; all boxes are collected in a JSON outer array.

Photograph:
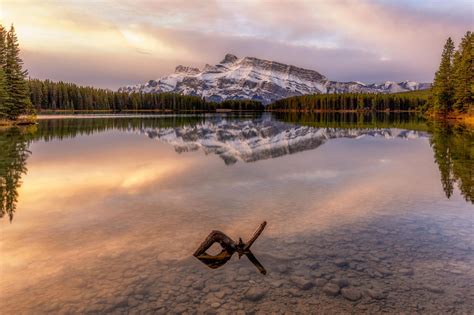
[[2, 216, 474, 314]]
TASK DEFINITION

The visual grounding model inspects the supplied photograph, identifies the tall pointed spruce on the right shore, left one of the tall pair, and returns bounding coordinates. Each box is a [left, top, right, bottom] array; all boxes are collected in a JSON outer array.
[[433, 37, 454, 114]]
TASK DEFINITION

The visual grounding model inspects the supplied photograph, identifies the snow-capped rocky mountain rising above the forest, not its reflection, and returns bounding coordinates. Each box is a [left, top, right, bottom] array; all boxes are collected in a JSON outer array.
[[119, 54, 431, 104]]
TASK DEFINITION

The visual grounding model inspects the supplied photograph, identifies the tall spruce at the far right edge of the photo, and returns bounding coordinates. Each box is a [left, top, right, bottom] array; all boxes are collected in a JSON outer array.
[[453, 31, 474, 112]]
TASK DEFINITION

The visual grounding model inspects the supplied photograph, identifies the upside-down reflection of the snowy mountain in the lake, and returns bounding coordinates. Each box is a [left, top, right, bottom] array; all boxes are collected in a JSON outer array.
[[136, 117, 427, 165]]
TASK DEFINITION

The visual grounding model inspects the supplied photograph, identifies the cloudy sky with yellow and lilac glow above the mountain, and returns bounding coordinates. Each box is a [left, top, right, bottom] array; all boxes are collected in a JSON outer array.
[[0, 0, 474, 89]]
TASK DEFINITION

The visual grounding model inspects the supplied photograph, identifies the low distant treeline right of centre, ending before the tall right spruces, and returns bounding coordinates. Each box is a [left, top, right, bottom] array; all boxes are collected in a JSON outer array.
[[267, 93, 428, 112]]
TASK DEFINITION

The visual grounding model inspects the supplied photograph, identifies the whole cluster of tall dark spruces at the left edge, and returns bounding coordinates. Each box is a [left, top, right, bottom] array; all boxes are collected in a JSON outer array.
[[0, 24, 34, 122]]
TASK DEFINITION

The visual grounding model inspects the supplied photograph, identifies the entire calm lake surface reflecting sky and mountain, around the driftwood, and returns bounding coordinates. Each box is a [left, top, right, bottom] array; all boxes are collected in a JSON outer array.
[[0, 114, 474, 314]]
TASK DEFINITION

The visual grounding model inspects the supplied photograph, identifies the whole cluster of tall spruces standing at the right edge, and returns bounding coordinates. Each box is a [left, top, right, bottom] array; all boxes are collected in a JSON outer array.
[[430, 32, 474, 114]]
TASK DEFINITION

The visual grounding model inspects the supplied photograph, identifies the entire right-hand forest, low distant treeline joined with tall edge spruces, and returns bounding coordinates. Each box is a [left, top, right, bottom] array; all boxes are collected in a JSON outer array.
[[267, 31, 474, 117]]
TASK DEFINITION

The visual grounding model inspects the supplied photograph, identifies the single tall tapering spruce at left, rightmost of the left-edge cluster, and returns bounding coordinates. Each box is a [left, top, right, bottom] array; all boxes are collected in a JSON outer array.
[[4, 25, 32, 120]]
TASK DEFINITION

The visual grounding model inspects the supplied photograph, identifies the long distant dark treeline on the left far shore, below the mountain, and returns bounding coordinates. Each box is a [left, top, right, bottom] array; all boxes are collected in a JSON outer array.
[[28, 79, 264, 112]]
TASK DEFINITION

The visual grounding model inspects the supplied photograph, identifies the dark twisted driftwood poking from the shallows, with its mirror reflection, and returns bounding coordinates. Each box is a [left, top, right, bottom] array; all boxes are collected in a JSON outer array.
[[194, 221, 267, 274]]
